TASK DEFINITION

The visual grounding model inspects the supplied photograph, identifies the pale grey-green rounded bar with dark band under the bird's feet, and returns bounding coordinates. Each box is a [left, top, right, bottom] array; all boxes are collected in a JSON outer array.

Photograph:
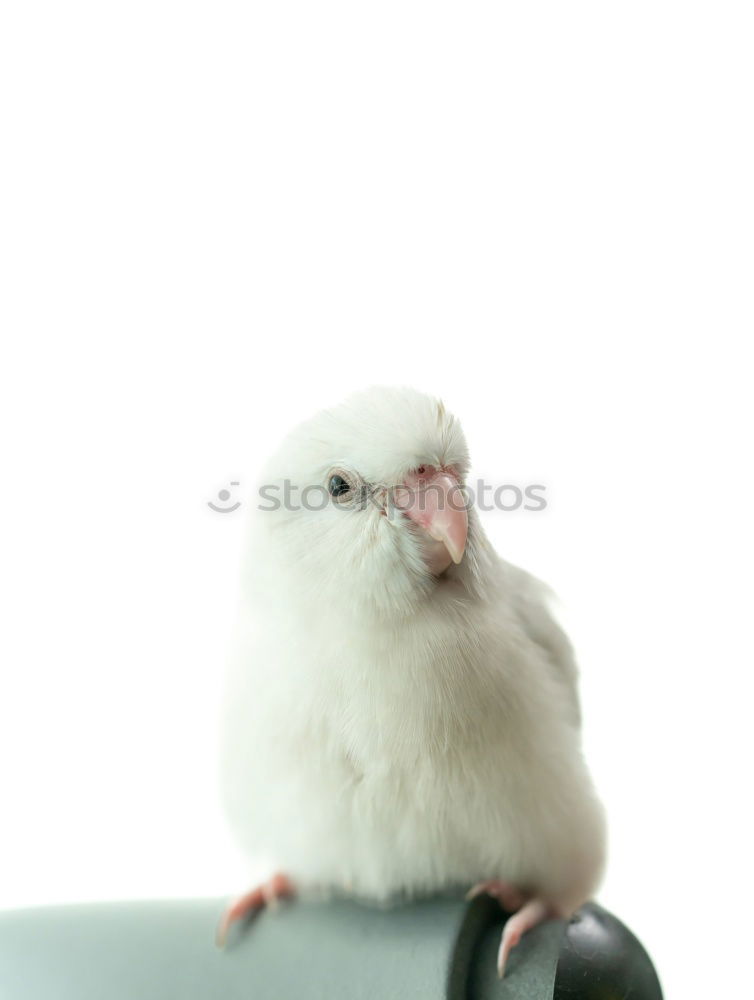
[[0, 898, 564, 1000]]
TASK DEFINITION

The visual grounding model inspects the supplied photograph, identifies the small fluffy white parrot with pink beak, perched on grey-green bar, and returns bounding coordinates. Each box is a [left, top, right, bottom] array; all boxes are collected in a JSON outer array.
[[219, 388, 605, 975]]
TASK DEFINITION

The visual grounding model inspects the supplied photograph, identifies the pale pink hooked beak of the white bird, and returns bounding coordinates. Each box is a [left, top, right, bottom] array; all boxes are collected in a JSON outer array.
[[396, 466, 469, 566]]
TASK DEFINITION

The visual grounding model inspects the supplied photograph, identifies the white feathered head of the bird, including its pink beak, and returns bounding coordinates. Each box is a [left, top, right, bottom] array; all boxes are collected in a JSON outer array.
[[253, 387, 483, 615]]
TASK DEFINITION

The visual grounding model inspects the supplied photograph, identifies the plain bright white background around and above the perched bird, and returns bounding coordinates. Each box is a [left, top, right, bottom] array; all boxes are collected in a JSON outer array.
[[0, 0, 754, 997]]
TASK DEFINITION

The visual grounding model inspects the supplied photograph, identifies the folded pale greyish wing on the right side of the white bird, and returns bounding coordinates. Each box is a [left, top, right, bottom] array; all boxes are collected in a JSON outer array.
[[511, 566, 581, 726]]
